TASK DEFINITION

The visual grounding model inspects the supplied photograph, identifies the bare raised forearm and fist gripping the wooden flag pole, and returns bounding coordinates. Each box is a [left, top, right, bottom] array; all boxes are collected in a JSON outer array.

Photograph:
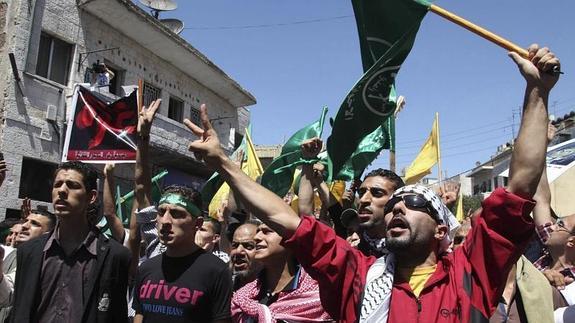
[[508, 45, 560, 198]]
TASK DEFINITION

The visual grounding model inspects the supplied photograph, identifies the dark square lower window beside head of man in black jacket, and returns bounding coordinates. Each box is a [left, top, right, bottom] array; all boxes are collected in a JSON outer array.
[[18, 157, 58, 202]]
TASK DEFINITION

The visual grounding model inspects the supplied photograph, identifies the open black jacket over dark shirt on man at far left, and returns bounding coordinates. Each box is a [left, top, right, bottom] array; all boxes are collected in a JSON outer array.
[[10, 232, 130, 323]]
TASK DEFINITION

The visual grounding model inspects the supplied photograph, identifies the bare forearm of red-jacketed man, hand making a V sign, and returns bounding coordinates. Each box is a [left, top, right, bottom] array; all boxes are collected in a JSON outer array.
[[184, 105, 300, 238]]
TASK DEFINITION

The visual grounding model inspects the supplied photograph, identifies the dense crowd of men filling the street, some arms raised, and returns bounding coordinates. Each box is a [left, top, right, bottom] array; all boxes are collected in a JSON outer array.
[[0, 45, 575, 323]]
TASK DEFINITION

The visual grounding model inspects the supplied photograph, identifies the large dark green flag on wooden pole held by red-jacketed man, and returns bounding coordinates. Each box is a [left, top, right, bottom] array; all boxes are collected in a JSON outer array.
[[327, 0, 430, 180]]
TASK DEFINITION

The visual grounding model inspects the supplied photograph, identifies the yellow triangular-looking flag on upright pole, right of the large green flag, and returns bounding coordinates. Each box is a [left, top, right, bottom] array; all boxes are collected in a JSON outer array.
[[405, 113, 440, 184]]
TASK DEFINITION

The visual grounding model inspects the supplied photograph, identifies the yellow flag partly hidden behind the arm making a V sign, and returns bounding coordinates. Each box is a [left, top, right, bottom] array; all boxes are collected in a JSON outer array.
[[208, 129, 264, 218]]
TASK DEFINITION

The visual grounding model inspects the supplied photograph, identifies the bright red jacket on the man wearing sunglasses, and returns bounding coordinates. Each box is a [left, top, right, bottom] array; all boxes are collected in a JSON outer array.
[[284, 188, 535, 323]]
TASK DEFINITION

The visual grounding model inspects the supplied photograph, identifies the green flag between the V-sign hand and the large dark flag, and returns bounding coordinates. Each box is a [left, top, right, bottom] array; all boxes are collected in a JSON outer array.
[[262, 107, 327, 197]]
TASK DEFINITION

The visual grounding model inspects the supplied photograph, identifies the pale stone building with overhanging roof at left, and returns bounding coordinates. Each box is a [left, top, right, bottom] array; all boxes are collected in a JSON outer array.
[[0, 0, 256, 218]]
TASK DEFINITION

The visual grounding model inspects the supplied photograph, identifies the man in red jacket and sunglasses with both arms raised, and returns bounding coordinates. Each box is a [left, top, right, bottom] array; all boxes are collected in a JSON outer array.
[[185, 45, 559, 322]]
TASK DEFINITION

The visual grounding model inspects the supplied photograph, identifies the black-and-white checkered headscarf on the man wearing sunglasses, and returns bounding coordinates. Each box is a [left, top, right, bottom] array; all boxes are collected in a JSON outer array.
[[393, 185, 460, 253]]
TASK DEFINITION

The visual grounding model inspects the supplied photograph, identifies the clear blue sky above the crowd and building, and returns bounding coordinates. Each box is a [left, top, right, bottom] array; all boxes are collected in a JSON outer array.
[[138, 0, 575, 177]]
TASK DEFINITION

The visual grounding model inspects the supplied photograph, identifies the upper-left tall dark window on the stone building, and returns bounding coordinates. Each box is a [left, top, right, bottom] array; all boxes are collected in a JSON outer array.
[[36, 32, 73, 85]]
